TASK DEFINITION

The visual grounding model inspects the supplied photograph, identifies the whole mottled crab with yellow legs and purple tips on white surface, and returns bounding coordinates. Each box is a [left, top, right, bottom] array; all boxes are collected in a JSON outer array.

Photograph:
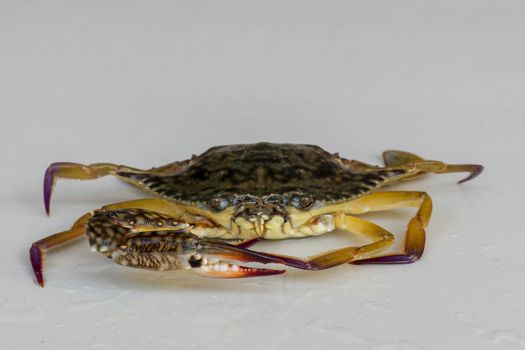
[[30, 142, 483, 287]]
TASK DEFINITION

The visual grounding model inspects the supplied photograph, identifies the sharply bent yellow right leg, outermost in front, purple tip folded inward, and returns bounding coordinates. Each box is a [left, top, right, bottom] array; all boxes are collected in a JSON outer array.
[[348, 192, 432, 264]]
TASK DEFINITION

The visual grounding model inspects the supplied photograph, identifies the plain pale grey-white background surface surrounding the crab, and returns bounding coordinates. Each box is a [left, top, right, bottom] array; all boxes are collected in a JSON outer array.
[[0, 0, 525, 350]]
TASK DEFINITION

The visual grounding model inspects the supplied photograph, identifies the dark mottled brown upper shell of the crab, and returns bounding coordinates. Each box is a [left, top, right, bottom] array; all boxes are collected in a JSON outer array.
[[118, 142, 405, 210]]
